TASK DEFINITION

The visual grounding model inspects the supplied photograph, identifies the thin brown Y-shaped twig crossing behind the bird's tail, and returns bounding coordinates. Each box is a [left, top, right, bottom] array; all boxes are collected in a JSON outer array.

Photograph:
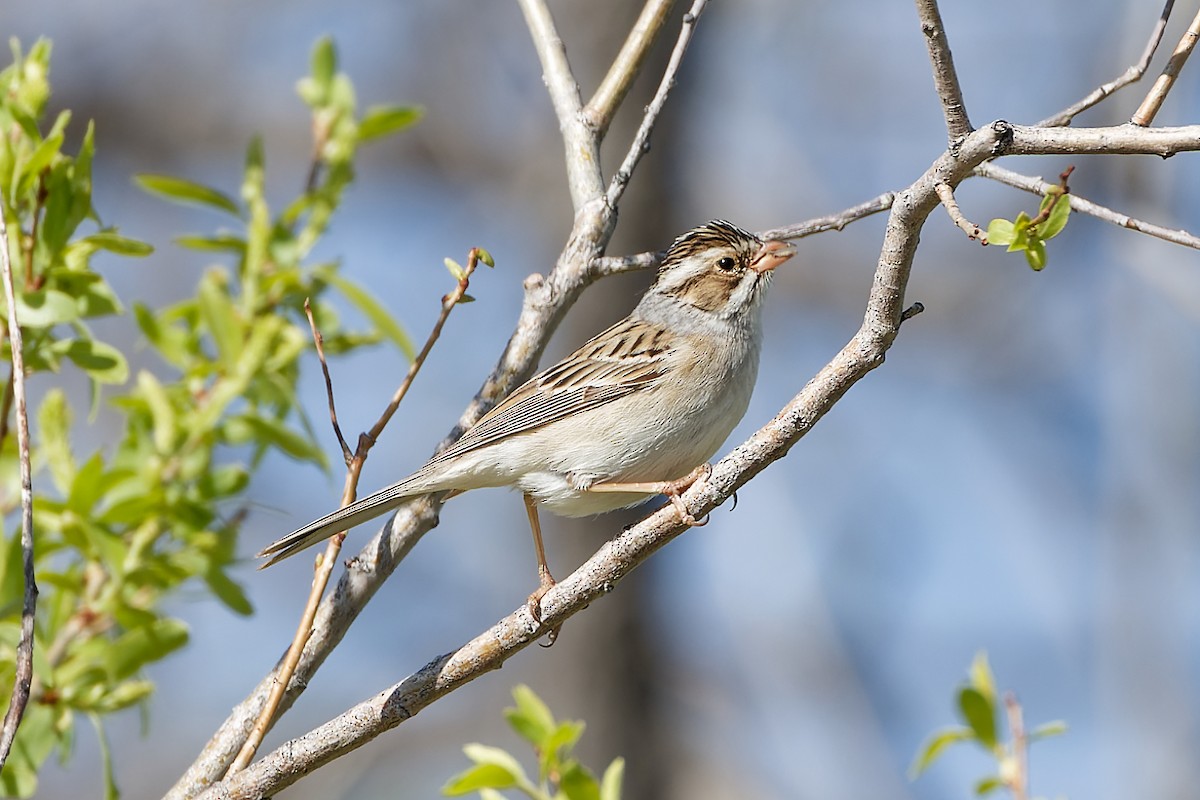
[[226, 247, 479, 777]]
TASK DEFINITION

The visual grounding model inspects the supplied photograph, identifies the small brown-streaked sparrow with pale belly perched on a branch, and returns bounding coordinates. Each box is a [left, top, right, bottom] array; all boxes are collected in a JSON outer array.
[[258, 219, 796, 621]]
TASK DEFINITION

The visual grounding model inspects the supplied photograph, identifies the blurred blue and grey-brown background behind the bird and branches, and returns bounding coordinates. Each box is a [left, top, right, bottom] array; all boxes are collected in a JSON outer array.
[[0, 0, 1200, 800]]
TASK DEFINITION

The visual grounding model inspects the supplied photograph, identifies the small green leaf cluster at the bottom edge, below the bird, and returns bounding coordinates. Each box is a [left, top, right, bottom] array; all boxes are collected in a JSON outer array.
[[442, 685, 625, 800]]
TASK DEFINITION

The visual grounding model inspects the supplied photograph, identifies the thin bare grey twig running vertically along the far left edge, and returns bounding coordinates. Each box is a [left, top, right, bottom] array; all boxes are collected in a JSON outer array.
[[0, 194, 37, 768]]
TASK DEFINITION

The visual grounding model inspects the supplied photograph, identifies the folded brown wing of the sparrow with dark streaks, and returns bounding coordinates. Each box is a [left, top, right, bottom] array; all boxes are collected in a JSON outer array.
[[433, 319, 671, 463]]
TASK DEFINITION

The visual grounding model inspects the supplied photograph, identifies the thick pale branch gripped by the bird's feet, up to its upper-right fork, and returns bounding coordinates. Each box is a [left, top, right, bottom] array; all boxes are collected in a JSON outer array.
[[189, 118, 1041, 798]]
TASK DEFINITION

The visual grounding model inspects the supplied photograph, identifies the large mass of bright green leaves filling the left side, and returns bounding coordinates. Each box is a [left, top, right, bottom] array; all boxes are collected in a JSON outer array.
[[0, 40, 419, 796]]
